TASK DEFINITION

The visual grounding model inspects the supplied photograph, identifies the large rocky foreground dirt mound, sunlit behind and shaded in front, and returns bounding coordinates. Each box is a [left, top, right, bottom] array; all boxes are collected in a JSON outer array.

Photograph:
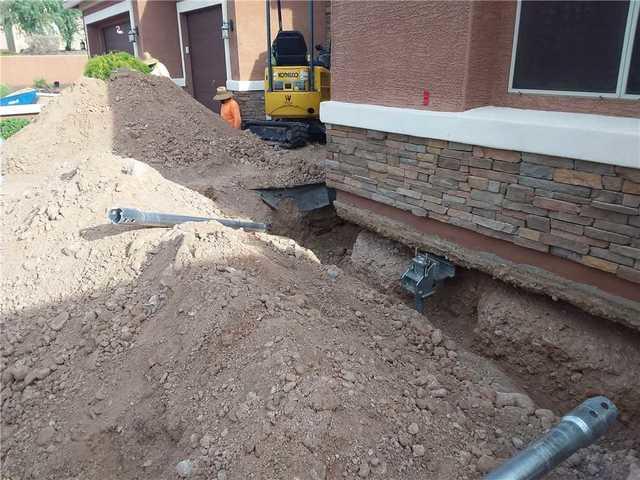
[[0, 72, 637, 480]]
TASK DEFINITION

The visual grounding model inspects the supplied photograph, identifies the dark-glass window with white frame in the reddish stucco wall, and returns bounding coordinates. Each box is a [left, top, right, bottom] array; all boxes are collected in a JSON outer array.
[[509, 0, 640, 98]]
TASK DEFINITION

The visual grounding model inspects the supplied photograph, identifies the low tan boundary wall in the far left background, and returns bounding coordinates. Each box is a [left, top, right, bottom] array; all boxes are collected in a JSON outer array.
[[0, 54, 87, 87]]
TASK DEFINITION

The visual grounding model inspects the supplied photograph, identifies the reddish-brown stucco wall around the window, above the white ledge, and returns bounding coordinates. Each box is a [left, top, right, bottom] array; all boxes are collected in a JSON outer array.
[[331, 1, 640, 117]]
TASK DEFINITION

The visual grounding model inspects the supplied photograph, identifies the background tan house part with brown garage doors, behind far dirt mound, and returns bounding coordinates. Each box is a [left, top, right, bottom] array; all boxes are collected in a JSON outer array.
[[65, 0, 328, 114]]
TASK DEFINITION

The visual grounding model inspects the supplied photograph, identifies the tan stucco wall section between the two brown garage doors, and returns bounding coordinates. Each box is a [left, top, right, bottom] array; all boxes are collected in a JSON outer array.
[[134, 0, 184, 78]]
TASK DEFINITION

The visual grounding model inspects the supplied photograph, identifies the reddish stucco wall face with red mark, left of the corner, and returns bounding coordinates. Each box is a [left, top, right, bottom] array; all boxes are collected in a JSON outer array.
[[331, 1, 472, 111]]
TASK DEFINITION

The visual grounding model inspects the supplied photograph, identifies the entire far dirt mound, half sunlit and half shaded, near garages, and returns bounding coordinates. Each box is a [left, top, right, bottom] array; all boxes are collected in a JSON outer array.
[[4, 71, 324, 187]]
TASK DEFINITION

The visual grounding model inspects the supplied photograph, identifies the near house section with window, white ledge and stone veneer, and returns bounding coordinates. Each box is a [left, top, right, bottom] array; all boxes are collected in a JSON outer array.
[[320, 1, 640, 326]]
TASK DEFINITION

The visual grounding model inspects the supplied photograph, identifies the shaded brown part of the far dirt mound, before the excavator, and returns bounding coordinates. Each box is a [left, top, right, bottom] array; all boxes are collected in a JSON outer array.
[[108, 71, 324, 186]]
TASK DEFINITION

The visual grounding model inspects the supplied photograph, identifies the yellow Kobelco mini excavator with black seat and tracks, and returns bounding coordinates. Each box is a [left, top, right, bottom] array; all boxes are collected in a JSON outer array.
[[245, 0, 331, 148]]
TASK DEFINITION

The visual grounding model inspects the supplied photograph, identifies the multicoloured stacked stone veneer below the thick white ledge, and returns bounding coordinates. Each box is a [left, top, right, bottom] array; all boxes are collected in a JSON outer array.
[[327, 125, 640, 283]]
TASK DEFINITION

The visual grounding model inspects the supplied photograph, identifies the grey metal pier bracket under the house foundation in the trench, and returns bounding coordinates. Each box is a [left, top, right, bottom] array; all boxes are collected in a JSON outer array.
[[400, 252, 456, 312]]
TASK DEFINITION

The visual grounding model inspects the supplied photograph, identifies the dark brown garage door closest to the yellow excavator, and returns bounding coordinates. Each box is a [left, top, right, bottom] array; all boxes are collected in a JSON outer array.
[[187, 5, 227, 112]]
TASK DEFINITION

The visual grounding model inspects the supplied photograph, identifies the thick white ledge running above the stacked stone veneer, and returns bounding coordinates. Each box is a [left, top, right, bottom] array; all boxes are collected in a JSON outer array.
[[320, 102, 640, 168]]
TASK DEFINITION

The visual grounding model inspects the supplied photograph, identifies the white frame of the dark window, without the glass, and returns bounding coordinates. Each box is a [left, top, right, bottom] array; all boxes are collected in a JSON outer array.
[[507, 0, 640, 100]]
